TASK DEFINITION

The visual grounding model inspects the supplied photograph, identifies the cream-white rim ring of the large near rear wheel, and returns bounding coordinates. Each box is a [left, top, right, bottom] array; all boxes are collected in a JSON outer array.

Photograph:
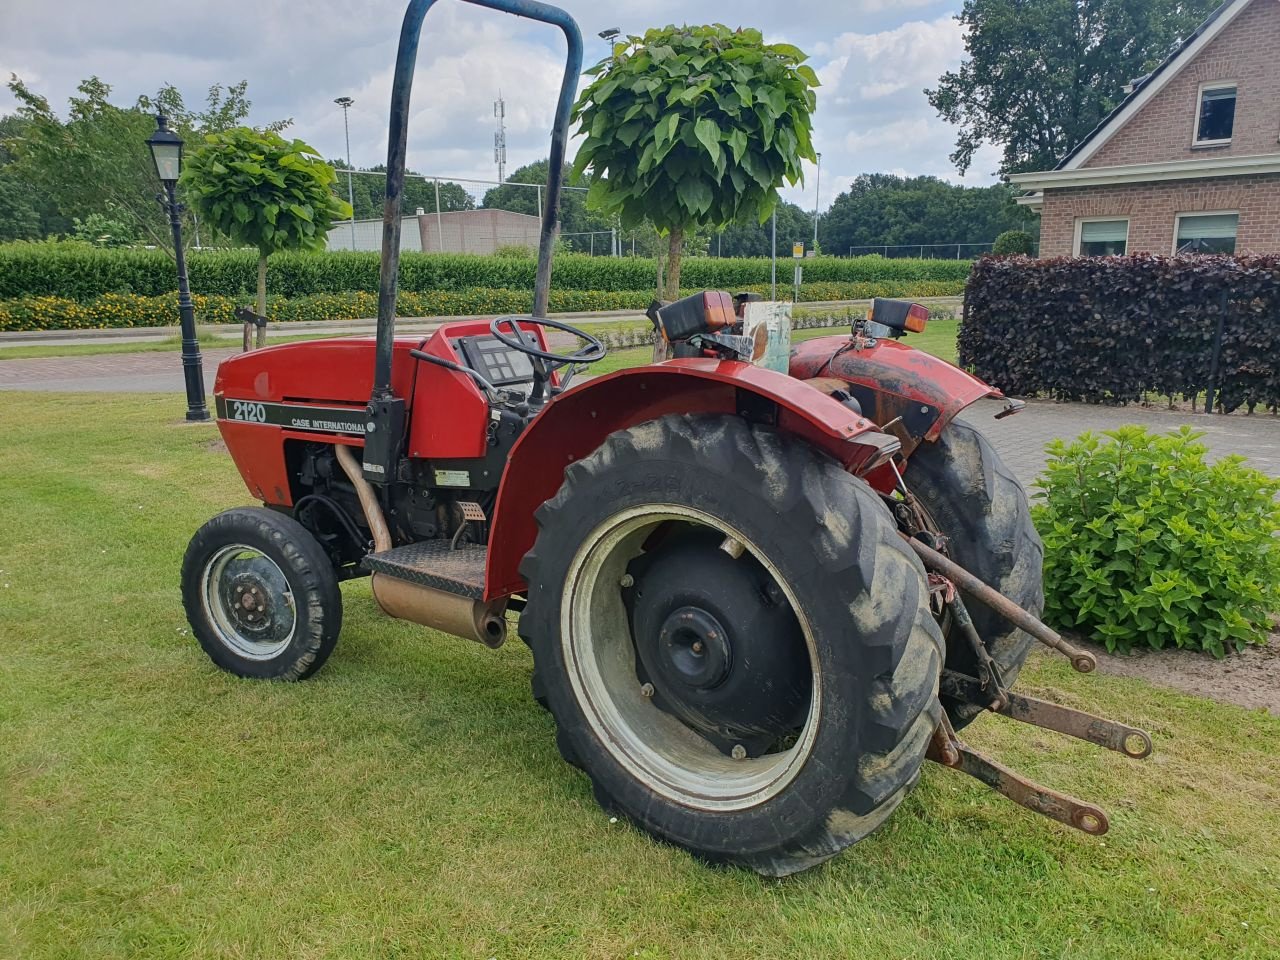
[[559, 503, 822, 812]]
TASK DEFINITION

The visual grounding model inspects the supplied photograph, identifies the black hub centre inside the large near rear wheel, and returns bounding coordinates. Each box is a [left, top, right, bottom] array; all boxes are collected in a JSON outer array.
[[623, 531, 812, 756]]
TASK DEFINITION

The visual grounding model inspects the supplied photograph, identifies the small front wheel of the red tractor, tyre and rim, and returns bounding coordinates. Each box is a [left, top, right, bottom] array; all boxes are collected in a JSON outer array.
[[182, 507, 342, 680]]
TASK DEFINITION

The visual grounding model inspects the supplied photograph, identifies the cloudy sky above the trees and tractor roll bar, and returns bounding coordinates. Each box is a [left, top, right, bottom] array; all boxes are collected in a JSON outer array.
[[0, 0, 998, 207]]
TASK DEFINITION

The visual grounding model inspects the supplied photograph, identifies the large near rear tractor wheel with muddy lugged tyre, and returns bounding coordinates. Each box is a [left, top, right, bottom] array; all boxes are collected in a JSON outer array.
[[520, 416, 942, 876]]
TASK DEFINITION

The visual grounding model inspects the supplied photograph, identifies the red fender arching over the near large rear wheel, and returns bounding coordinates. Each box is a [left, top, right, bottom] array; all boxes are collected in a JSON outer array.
[[485, 358, 899, 599]]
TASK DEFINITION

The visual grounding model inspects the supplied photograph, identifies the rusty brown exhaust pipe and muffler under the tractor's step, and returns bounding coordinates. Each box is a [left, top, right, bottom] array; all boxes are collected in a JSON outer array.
[[334, 443, 507, 650]]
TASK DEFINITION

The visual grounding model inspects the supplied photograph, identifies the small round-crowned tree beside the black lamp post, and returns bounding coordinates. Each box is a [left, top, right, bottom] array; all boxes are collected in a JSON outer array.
[[182, 127, 351, 348]]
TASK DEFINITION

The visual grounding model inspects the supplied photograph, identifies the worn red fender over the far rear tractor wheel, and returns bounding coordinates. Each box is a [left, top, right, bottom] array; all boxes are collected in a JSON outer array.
[[790, 337, 1005, 456]]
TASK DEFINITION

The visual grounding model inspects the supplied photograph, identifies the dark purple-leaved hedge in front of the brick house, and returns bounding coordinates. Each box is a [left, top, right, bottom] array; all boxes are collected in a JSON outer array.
[[957, 255, 1280, 412]]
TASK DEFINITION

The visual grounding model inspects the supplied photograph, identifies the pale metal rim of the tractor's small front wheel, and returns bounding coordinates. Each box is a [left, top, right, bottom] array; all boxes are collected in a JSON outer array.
[[200, 544, 298, 660]]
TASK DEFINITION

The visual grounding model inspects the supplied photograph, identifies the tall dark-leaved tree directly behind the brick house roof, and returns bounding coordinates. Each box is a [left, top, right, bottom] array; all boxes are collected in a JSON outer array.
[[924, 0, 1220, 174]]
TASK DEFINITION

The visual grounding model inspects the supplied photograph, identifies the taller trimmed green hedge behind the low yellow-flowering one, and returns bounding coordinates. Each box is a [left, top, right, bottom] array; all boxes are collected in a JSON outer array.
[[0, 243, 969, 303]]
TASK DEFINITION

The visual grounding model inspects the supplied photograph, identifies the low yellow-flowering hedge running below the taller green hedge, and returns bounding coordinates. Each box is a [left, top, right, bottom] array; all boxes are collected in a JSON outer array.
[[0, 280, 961, 332]]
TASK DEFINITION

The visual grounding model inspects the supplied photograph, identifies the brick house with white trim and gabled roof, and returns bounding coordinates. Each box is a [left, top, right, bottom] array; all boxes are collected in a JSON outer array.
[[1009, 0, 1280, 256]]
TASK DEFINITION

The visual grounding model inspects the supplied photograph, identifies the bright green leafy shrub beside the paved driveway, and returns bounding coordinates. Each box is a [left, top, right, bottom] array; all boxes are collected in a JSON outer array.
[[1033, 426, 1280, 657]]
